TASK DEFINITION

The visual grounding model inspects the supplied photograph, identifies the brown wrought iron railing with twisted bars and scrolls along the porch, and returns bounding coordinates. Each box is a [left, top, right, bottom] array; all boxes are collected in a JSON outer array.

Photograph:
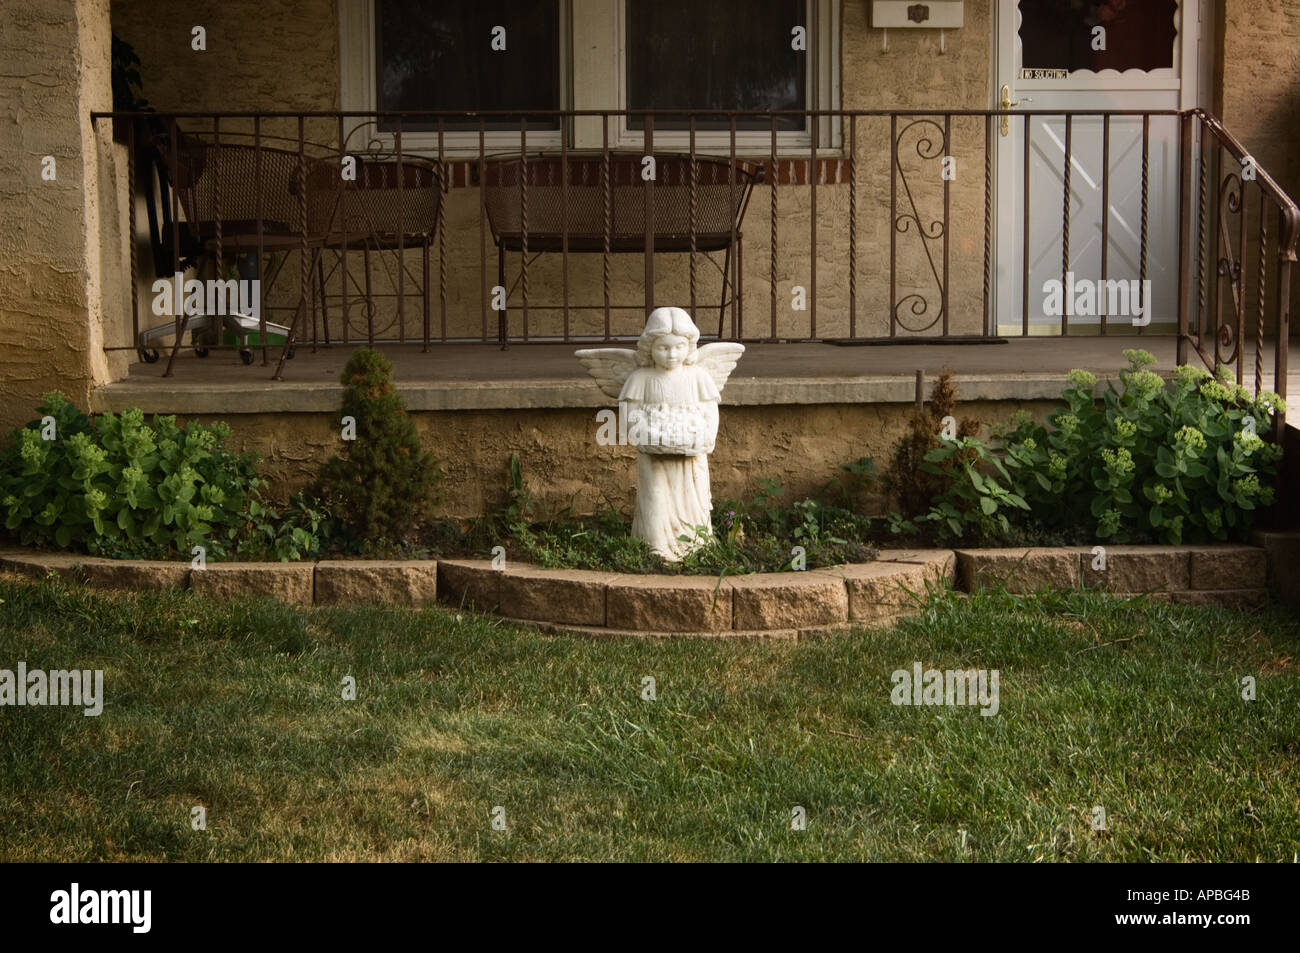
[[92, 111, 1300, 423]]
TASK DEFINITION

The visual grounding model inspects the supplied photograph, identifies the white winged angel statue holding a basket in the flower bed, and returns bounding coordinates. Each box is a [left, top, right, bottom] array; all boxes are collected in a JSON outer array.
[[575, 308, 745, 562]]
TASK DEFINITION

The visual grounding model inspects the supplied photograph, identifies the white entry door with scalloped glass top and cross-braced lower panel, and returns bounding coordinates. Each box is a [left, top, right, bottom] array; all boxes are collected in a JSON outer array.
[[993, 0, 1210, 334]]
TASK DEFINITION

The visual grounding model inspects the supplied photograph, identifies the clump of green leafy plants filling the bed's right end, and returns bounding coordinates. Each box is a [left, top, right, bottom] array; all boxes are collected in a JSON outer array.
[[889, 350, 1282, 545]]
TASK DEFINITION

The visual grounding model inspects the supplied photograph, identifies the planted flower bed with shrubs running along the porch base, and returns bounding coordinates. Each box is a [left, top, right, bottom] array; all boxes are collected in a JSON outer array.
[[0, 348, 1282, 590]]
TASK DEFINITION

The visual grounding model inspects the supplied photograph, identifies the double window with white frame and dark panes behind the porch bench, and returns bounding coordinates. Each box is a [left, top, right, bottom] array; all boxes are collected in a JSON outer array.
[[339, 0, 840, 157]]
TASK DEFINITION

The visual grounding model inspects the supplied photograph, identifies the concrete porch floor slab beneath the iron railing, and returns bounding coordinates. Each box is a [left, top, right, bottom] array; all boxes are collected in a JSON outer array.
[[94, 335, 1300, 420]]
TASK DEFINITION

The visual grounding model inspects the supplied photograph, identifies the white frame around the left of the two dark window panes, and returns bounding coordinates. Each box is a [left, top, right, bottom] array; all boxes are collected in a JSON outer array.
[[338, 0, 573, 159]]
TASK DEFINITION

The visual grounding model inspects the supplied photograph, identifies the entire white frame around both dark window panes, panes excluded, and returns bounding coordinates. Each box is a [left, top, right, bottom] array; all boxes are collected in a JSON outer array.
[[338, 0, 844, 159]]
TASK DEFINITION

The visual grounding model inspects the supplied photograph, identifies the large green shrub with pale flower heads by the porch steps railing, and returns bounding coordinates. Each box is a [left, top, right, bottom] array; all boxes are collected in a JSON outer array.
[[1004, 350, 1282, 543]]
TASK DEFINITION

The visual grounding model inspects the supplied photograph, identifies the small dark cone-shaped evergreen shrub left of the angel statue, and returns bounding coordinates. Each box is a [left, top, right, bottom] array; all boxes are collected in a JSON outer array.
[[312, 347, 442, 553]]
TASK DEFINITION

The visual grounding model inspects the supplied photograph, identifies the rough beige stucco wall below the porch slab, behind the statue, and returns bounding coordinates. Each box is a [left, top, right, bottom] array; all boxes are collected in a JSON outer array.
[[185, 400, 1056, 517]]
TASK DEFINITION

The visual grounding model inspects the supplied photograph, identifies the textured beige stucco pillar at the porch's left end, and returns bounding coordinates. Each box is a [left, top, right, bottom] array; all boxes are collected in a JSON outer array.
[[0, 0, 117, 426]]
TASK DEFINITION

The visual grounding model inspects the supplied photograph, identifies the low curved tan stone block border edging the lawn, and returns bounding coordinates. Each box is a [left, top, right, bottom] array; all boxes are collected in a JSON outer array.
[[0, 546, 1268, 640]]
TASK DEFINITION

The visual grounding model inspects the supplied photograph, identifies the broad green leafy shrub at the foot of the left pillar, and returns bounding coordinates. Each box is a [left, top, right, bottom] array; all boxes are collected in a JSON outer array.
[[0, 391, 316, 559]]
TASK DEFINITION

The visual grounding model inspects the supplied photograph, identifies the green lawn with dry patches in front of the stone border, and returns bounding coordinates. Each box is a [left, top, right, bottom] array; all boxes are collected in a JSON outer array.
[[0, 577, 1300, 861]]
